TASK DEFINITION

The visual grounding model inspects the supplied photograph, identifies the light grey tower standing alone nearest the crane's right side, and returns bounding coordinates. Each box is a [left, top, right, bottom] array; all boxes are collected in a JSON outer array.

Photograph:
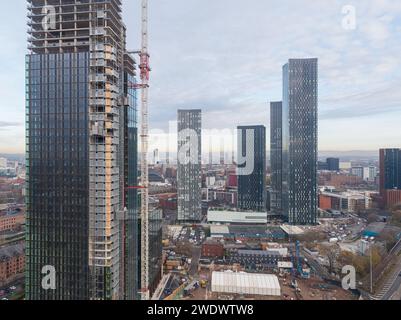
[[177, 110, 202, 222]]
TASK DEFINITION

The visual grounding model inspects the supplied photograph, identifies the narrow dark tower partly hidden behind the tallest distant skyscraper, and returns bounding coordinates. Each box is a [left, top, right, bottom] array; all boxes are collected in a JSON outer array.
[[270, 101, 283, 212]]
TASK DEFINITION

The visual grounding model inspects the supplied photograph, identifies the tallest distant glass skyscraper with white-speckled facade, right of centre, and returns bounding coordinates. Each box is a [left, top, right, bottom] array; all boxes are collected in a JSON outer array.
[[282, 59, 318, 225]]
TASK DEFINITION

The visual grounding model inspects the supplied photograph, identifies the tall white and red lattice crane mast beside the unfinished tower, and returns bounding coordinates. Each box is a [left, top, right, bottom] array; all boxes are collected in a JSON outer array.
[[139, 0, 150, 300]]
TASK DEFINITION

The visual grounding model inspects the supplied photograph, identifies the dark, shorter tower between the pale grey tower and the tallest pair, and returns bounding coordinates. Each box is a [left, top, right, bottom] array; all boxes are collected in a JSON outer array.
[[237, 126, 266, 212]]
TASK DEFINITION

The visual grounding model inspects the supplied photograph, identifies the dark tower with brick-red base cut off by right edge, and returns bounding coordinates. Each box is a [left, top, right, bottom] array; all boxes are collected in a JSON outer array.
[[380, 149, 401, 208]]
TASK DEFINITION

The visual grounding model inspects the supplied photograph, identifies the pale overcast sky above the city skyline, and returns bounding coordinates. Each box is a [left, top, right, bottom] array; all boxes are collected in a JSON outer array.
[[0, 0, 401, 153]]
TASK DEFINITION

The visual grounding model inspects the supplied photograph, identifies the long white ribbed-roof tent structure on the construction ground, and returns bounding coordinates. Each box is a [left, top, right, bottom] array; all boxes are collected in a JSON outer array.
[[212, 272, 281, 296]]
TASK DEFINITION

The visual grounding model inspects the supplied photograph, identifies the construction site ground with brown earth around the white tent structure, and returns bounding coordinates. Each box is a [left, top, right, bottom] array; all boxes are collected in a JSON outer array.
[[153, 222, 359, 300]]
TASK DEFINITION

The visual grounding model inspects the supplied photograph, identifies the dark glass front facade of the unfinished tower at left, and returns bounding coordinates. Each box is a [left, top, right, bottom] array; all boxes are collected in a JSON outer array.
[[26, 52, 89, 300]]
